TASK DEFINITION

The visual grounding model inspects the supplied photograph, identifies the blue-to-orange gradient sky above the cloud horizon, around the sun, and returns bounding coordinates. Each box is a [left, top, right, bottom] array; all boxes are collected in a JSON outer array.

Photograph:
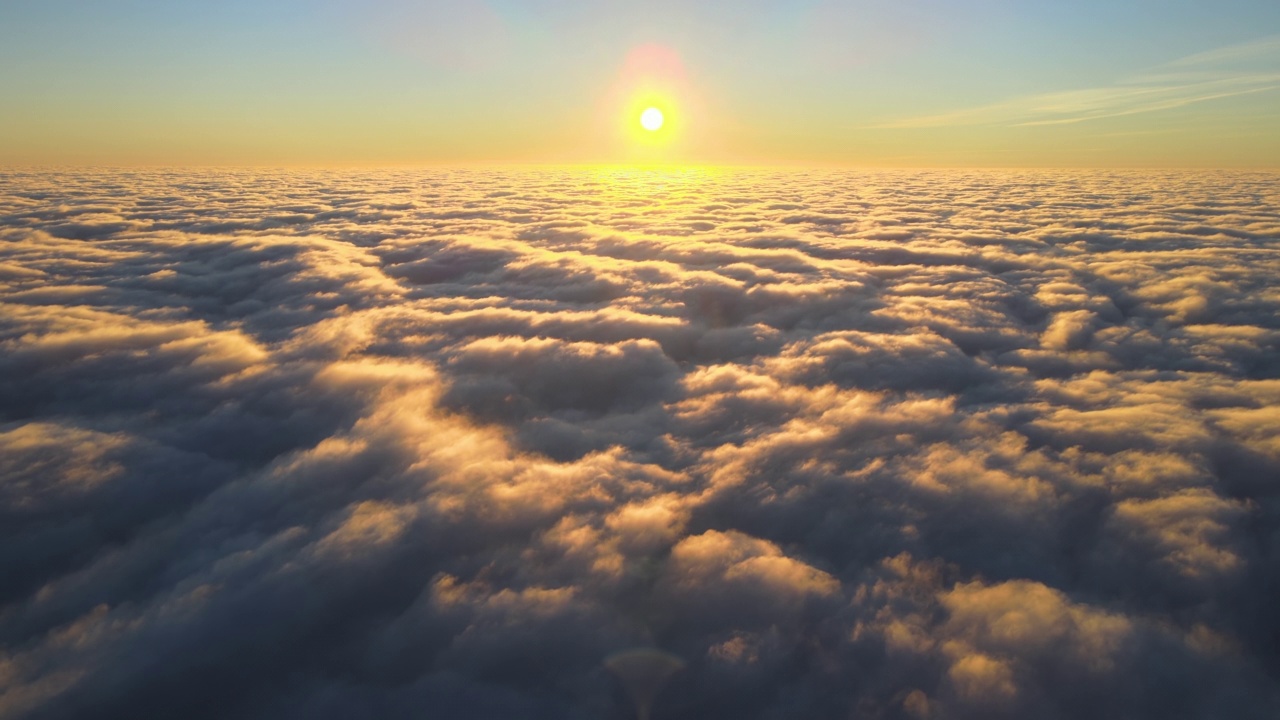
[[0, 0, 1280, 167]]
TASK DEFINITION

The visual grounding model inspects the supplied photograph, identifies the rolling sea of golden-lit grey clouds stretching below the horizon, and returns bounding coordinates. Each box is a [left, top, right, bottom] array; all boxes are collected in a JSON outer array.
[[0, 169, 1280, 720]]
